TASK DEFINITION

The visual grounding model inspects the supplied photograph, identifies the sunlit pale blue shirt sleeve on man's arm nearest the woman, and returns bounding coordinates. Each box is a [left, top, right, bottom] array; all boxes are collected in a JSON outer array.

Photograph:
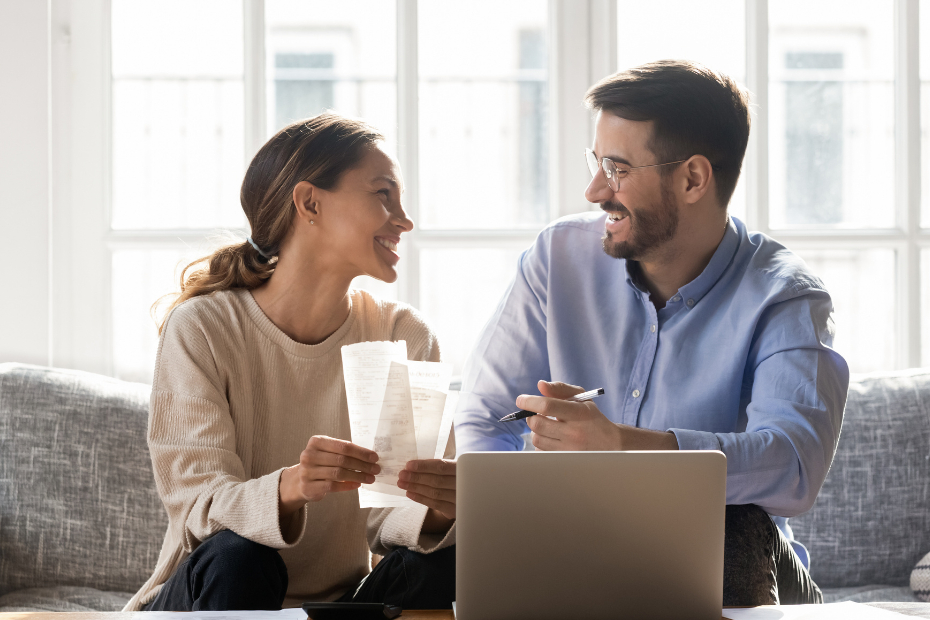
[[455, 235, 550, 454]]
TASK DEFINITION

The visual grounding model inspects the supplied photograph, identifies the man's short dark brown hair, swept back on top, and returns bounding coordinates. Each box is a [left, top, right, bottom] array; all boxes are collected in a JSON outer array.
[[585, 60, 750, 206]]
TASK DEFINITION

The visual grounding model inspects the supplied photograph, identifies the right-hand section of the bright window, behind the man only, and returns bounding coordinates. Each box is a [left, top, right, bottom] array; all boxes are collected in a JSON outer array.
[[617, 0, 930, 372]]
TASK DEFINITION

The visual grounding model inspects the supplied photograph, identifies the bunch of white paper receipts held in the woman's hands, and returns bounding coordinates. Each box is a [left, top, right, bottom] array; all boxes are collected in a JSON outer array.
[[342, 340, 457, 508]]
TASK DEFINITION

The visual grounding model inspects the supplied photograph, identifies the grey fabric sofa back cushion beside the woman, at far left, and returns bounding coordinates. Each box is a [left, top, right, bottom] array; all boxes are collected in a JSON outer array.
[[0, 364, 168, 595]]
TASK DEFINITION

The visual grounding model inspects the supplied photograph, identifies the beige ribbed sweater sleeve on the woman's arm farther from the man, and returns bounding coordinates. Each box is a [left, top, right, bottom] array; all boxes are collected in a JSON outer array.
[[148, 303, 307, 553]]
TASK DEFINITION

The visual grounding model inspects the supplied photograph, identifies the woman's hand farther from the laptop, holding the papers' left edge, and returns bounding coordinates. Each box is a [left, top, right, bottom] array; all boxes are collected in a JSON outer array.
[[279, 435, 381, 517]]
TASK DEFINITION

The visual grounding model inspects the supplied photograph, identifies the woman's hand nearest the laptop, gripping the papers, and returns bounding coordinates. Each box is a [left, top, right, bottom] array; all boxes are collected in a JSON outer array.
[[397, 459, 455, 534]]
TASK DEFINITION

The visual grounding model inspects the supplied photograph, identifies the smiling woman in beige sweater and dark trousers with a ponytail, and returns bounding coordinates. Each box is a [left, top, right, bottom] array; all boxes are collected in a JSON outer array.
[[126, 114, 455, 611]]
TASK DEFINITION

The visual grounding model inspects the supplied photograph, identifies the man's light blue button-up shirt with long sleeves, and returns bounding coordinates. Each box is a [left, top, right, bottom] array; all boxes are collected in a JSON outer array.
[[455, 212, 849, 565]]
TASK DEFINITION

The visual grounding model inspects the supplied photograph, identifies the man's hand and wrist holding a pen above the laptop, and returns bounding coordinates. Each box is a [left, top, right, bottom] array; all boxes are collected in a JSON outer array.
[[516, 381, 678, 451]]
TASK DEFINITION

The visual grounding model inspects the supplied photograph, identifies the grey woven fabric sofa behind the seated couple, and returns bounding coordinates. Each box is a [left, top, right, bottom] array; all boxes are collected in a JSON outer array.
[[0, 363, 930, 618]]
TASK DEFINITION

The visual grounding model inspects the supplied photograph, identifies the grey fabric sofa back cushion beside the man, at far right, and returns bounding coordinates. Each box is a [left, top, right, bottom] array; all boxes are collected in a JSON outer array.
[[790, 369, 930, 588]]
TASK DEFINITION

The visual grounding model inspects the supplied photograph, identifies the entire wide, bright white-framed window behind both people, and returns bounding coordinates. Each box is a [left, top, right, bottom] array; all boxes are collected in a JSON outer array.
[[98, 0, 930, 381]]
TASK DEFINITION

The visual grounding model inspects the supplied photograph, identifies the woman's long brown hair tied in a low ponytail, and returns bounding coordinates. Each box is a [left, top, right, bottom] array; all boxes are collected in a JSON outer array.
[[153, 112, 384, 332]]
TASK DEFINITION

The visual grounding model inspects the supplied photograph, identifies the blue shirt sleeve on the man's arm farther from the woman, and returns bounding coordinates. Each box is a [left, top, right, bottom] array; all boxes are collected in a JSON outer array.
[[670, 291, 849, 517]]
